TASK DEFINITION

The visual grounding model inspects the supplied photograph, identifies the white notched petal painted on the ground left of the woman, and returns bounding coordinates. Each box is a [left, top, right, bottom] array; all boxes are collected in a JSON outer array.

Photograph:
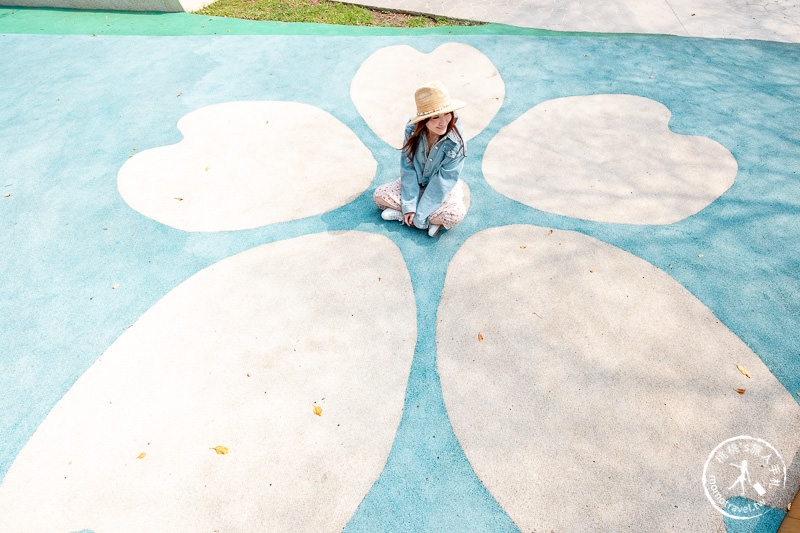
[[118, 102, 377, 231]]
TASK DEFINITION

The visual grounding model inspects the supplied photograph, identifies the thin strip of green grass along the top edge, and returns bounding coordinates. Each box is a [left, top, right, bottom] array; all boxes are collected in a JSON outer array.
[[196, 0, 482, 28]]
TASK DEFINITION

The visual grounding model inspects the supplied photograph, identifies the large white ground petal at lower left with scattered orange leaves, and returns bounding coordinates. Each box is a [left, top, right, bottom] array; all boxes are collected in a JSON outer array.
[[0, 232, 416, 533]]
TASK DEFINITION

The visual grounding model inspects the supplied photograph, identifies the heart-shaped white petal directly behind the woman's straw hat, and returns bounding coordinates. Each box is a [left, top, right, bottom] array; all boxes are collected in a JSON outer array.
[[350, 43, 505, 148]]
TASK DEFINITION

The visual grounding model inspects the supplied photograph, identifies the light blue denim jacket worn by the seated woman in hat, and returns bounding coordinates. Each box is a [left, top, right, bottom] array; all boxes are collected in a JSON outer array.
[[400, 119, 464, 229]]
